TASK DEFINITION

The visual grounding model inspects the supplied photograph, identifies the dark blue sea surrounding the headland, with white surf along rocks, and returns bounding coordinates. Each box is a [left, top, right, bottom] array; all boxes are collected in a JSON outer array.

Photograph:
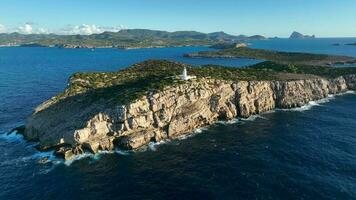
[[0, 38, 356, 200]]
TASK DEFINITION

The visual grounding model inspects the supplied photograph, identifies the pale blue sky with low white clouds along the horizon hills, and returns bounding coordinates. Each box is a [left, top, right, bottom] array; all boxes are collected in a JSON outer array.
[[0, 0, 356, 37]]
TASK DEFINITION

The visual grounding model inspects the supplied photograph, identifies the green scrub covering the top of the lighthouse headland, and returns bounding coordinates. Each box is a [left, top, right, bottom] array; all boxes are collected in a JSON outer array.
[[47, 60, 356, 107]]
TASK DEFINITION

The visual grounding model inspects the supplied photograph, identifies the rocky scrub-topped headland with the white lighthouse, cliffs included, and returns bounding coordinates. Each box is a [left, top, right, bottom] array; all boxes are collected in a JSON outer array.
[[23, 57, 356, 159]]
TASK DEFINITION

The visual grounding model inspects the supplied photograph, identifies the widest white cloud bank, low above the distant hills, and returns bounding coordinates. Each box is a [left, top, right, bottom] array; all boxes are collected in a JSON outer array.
[[57, 24, 124, 35]]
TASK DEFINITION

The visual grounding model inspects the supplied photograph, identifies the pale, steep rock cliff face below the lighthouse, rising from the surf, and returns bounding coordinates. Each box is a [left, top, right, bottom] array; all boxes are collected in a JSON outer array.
[[24, 75, 356, 159]]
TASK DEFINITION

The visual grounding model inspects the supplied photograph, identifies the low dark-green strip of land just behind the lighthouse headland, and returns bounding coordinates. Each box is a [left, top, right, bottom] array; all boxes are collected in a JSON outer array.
[[185, 48, 356, 65]]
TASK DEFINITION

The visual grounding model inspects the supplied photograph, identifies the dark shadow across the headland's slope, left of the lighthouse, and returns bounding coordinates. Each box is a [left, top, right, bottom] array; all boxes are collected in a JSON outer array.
[[29, 75, 175, 137]]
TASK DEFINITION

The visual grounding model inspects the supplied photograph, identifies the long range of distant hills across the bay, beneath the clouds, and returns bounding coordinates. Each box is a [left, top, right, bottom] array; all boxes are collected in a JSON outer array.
[[0, 29, 266, 49]]
